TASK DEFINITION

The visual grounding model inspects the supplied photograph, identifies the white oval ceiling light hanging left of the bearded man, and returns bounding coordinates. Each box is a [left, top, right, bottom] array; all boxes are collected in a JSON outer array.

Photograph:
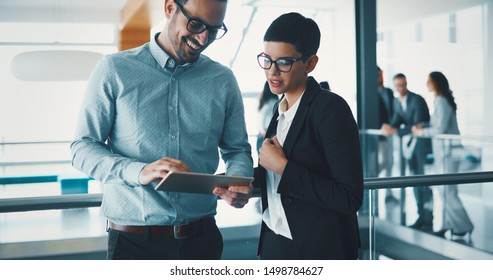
[[10, 50, 103, 82]]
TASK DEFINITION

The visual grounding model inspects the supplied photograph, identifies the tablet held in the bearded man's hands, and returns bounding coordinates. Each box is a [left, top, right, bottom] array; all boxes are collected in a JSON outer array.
[[155, 172, 254, 194]]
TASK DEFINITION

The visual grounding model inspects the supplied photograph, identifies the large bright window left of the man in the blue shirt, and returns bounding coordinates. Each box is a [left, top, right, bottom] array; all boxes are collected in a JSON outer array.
[[0, 22, 117, 179]]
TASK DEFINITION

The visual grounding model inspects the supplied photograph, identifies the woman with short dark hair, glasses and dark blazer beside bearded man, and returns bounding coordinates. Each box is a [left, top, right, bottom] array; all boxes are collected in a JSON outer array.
[[254, 13, 363, 260]]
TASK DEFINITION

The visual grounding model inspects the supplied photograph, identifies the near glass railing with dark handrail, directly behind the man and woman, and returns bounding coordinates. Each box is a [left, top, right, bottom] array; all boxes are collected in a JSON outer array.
[[0, 172, 493, 259]]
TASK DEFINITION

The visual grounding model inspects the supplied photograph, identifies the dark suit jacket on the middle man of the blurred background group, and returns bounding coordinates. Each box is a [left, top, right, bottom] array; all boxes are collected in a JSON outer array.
[[390, 91, 431, 155]]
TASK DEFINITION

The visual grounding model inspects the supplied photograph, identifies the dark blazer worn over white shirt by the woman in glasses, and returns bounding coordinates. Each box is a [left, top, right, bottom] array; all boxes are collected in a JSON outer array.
[[254, 77, 363, 259]]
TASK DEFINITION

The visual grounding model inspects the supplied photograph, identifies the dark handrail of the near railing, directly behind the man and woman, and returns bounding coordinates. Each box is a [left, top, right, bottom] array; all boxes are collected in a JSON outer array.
[[0, 172, 493, 213]]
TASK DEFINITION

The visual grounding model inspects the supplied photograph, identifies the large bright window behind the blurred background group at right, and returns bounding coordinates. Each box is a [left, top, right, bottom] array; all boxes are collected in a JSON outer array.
[[377, 0, 493, 135]]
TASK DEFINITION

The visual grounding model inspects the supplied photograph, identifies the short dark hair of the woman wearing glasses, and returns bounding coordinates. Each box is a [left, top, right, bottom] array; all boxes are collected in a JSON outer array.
[[264, 13, 320, 57]]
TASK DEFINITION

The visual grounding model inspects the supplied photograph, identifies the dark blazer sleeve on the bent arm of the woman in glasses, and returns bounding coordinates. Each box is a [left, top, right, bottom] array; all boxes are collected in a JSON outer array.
[[278, 98, 363, 215]]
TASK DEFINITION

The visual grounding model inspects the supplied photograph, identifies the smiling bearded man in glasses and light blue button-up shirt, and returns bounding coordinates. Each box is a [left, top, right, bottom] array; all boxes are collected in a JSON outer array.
[[71, 0, 253, 259]]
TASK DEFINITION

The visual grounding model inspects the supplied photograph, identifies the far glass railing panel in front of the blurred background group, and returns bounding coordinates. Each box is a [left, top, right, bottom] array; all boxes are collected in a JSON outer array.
[[360, 129, 493, 178]]
